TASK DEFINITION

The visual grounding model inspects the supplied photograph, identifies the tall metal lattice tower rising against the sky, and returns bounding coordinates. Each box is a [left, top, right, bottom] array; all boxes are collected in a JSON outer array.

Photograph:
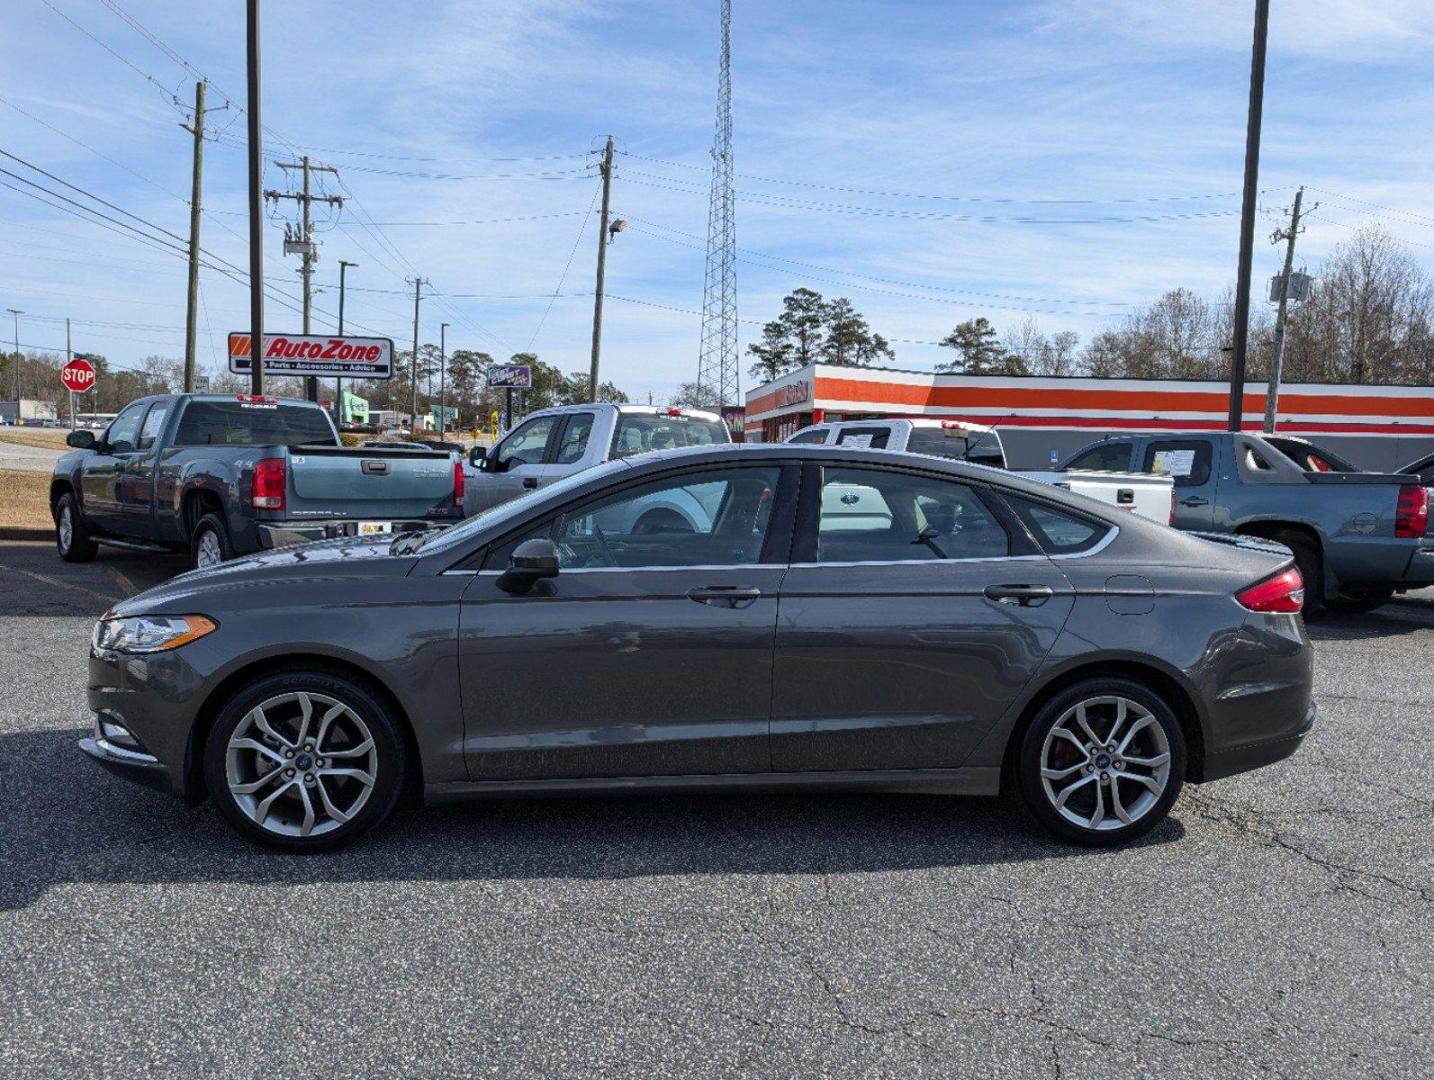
[[697, 0, 741, 404]]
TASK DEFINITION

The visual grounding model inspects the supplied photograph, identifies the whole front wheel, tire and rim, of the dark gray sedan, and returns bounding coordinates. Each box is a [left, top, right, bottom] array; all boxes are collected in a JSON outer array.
[[204, 670, 407, 852]]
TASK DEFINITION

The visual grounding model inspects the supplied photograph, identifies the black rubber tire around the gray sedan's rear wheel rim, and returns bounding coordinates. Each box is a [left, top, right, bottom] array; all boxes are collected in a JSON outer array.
[[1012, 676, 1186, 848]]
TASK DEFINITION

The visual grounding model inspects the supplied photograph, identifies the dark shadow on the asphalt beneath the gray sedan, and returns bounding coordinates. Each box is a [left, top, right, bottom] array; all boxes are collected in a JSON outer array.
[[0, 729, 1184, 909]]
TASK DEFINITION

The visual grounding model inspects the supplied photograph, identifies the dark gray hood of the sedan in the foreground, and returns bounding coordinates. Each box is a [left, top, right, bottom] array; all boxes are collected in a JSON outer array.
[[110, 536, 417, 615]]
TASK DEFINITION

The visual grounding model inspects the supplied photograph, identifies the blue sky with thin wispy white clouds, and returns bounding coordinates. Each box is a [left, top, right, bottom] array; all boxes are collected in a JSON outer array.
[[0, 0, 1434, 403]]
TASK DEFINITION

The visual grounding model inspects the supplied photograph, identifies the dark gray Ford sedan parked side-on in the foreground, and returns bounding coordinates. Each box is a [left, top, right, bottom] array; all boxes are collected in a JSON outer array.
[[80, 445, 1315, 852]]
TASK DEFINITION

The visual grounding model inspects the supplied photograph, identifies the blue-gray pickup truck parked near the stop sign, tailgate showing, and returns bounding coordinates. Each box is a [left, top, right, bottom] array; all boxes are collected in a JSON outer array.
[[50, 394, 463, 567]]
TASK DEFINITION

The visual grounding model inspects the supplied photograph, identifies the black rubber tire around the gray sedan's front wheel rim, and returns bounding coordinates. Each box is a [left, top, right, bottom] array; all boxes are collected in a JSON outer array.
[[204, 667, 409, 855]]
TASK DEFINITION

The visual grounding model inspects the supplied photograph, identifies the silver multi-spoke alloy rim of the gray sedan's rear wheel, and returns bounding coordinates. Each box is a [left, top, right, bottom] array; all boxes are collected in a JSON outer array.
[[1041, 696, 1170, 832]]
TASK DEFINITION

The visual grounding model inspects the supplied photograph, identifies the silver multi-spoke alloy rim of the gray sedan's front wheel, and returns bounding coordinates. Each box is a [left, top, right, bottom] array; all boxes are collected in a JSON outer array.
[[225, 691, 379, 838]]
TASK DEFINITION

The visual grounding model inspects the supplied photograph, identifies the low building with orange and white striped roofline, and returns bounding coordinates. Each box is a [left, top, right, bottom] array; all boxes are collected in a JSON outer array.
[[744, 364, 1434, 469]]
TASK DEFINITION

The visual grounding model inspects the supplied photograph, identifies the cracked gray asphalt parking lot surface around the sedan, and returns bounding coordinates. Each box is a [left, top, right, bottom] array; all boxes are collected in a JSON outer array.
[[0, 544, 1434, 1077]]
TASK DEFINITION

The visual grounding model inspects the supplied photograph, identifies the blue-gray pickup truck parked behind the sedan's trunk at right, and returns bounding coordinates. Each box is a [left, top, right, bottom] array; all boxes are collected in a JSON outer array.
[[1061, 432, 1434, 617]]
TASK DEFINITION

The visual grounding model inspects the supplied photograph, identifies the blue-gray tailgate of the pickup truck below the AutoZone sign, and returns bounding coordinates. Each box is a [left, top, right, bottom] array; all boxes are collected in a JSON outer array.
[[287, 446, 453, 519]]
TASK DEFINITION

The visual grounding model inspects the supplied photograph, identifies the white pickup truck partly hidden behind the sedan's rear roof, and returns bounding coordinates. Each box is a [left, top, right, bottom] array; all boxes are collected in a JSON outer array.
[[784, 420, 1174, 525]]
